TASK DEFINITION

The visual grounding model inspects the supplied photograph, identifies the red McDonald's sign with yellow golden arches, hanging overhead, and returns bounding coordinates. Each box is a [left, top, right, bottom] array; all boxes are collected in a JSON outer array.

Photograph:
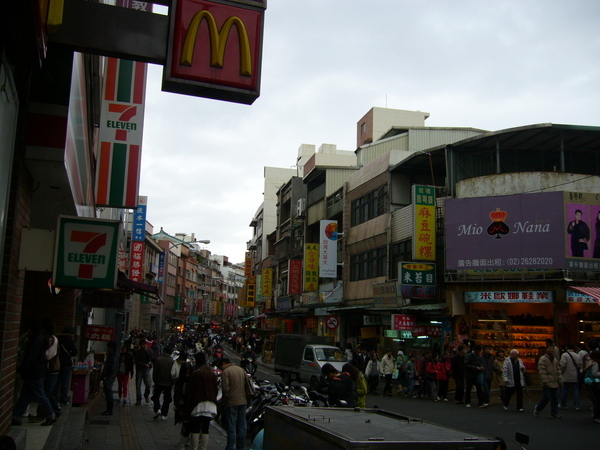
[[162, 0, 266, 104]]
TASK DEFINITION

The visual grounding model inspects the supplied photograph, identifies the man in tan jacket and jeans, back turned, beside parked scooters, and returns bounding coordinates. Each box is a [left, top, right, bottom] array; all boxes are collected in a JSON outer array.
[[220, 358, 248, 450]]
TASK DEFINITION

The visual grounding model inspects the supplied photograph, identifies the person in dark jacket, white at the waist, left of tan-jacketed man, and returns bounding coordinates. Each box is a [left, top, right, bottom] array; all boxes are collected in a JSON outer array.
[[184, 352, 220, 450]]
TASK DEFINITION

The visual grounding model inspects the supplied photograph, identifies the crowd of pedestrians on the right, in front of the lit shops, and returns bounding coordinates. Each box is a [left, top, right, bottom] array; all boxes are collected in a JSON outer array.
[[323, 339, 600, 423]]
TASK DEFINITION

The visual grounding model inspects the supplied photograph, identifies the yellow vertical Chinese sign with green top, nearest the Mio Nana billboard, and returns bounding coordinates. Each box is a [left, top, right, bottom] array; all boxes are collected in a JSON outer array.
[[412, 185, 435, 261]]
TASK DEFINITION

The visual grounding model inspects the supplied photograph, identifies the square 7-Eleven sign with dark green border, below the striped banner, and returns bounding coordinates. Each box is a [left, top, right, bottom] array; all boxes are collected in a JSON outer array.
[[52, 216, 121, 289]]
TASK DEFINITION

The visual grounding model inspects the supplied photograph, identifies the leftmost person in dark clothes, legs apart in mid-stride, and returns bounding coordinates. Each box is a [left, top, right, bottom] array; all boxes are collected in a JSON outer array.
[[12, 321, 56, 426]]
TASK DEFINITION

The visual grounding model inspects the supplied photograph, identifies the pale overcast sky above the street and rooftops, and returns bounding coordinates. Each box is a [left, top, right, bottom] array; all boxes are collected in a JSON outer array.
[[140, 0, 600, 262]]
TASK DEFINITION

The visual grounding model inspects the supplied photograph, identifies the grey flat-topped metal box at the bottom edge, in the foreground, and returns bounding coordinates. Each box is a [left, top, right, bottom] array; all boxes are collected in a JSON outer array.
[[263, 406, 501, 450]]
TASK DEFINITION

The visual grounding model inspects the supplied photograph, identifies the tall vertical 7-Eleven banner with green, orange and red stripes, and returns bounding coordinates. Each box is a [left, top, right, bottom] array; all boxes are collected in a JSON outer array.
[[96, 58, 146, 208]]
